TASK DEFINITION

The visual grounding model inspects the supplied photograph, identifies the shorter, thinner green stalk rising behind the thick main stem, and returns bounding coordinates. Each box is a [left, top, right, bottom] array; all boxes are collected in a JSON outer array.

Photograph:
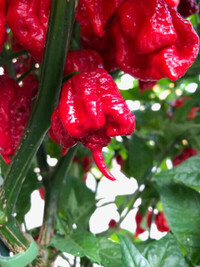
[[39, 146, 77, 246]]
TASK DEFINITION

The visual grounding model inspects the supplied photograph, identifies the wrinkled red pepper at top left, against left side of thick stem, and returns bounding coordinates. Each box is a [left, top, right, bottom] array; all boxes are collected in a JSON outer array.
[[6, 0, 51, 63]]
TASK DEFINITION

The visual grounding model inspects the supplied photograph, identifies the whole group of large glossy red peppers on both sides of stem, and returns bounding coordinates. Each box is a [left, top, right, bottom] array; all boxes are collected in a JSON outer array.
[[0, 0, 199, 180]]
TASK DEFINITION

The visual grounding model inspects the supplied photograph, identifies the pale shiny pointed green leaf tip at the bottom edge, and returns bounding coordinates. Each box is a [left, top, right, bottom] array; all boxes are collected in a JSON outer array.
[[119, 235, 151, 267]]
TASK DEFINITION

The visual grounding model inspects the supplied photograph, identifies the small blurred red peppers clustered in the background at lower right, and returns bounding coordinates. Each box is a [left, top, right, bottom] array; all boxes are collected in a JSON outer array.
[[135, 211, 170, 238]]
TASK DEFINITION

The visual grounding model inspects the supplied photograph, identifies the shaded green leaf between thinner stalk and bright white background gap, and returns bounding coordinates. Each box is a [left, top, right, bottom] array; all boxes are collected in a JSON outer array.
[[60, 177, 96, 230]]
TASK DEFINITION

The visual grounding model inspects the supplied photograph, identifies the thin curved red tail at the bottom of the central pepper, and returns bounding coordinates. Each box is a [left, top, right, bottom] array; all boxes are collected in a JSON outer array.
[[91, 148, 116, 181]]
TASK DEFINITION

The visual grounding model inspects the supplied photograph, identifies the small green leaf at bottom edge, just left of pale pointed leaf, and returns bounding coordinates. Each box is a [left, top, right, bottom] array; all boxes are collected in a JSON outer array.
[[99, 238, 122, 267]]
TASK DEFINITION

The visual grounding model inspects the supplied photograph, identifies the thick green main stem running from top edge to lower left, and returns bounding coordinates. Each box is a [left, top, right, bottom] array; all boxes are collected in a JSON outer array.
[[0, 0, 77, 253]]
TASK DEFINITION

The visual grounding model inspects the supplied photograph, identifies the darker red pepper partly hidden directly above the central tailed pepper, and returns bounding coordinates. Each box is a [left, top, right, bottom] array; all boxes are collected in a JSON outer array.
[[64, 49, 104, 75]]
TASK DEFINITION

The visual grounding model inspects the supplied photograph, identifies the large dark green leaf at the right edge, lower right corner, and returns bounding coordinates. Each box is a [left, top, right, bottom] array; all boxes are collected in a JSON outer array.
[[156, 178, 200, 264]]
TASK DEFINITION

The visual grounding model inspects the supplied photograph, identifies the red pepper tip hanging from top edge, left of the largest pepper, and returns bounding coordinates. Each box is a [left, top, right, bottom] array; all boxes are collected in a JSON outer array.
[[76, 0, 123, 36]]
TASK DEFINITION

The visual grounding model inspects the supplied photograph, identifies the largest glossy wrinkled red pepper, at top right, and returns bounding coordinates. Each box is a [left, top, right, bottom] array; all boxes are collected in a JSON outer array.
[[112, 0, 199, 81]]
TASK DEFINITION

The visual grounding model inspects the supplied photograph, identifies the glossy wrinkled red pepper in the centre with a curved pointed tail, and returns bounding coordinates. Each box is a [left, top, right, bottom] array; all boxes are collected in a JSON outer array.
[[50, 69, 135, 180]]
